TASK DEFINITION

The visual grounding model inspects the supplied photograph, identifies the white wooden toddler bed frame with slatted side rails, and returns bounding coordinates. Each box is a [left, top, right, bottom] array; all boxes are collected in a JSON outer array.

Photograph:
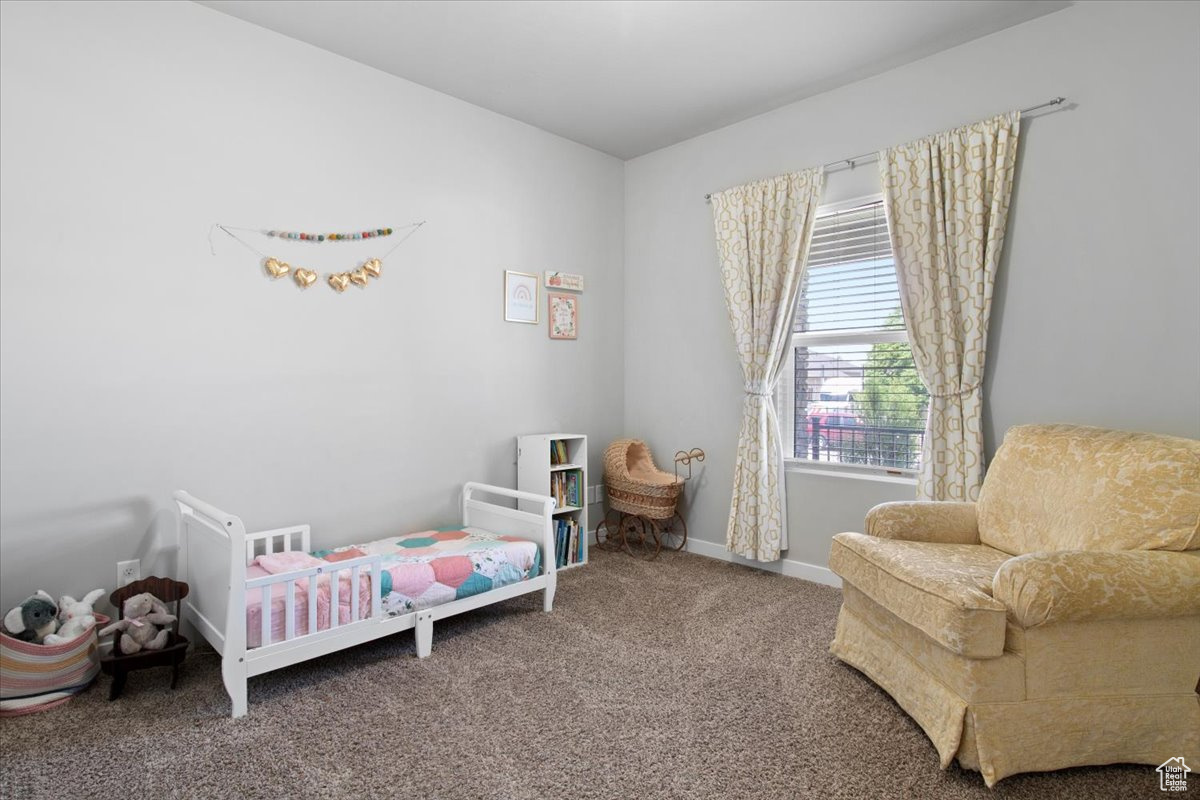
[[174, 483, 557, 717]]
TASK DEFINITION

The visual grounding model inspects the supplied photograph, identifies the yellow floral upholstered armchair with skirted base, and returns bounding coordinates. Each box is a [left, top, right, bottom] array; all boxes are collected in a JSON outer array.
[[829, 426, 1200, 787]]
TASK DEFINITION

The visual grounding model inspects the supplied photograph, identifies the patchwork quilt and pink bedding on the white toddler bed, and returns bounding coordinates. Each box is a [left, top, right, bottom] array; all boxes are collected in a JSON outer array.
[[246, 528, 541, 648]]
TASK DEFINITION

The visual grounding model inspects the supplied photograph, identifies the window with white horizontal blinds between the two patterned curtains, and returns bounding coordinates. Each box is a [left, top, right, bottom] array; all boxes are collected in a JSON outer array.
[[776, 199, 929, 470]]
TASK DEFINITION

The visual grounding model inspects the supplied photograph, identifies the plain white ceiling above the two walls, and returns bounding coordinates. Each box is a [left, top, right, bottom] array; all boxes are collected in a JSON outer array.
[[198, 0, 1070, 158]]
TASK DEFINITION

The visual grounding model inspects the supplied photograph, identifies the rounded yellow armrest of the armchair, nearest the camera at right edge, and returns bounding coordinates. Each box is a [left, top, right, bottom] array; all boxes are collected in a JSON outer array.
[[991, 551, 1200, 627]]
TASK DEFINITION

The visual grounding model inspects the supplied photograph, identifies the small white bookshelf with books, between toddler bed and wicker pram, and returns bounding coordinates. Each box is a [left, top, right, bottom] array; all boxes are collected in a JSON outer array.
[[517, 433, 588, 570]]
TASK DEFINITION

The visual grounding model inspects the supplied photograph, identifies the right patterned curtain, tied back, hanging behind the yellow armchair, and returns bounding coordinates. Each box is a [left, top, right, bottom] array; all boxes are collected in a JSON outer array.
[[880, 112, 1020, 500]]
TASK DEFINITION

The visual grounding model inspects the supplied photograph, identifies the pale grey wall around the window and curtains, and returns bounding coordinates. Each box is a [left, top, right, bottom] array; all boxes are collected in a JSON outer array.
[[625, 2, 1200, 573]]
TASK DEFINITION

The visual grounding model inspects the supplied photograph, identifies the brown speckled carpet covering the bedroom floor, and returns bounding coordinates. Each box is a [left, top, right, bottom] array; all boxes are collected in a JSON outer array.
[[0, 553, 1161, 800]]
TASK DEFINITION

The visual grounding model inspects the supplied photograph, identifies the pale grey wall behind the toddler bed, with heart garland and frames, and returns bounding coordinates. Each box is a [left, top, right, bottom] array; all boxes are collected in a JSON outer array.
[[0, 2, 623, 608]]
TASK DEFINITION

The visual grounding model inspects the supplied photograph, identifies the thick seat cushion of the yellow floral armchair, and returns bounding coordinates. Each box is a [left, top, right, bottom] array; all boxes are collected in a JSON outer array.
[[829, 533, 1009, 658]]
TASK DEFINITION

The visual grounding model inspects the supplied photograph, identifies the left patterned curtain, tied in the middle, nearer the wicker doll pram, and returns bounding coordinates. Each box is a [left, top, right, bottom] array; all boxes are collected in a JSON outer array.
[[712, 169, 824, 561]]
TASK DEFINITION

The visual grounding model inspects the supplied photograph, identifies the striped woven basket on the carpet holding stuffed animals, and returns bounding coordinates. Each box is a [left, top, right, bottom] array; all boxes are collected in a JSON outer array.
[[0, 614, 109, 716]]
